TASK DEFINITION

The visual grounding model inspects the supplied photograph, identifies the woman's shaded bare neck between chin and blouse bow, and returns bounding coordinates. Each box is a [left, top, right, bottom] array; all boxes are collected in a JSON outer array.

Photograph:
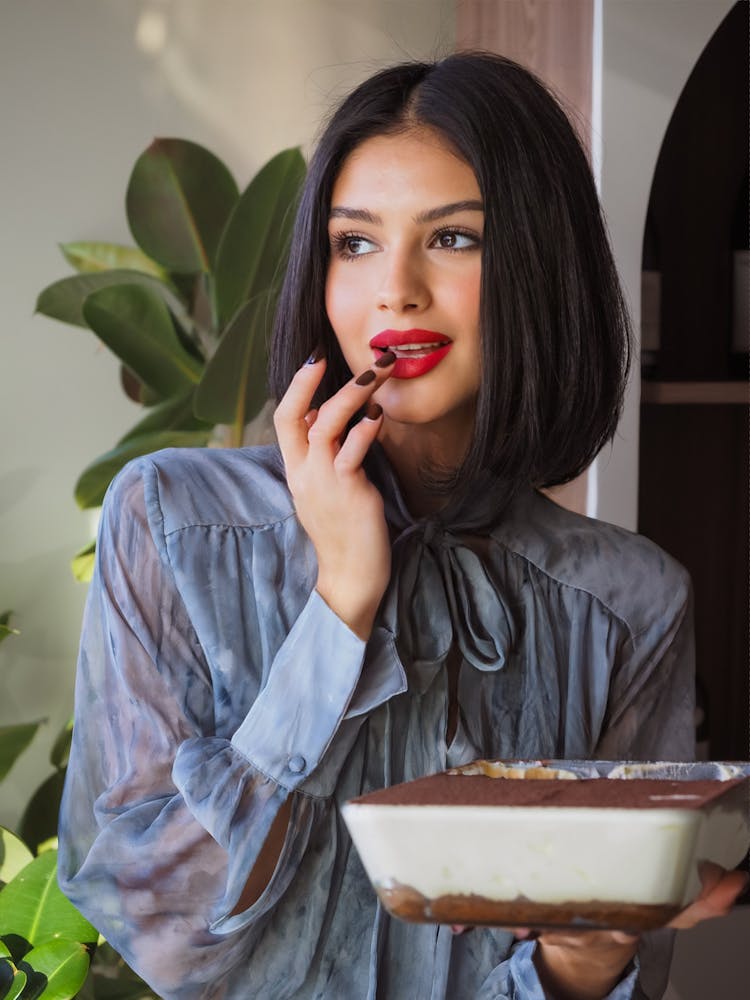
[[379, 417, 471, 517]]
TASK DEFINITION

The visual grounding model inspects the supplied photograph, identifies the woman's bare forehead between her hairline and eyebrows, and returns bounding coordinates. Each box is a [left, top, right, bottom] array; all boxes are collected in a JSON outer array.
[[331, 128, 480, 207]]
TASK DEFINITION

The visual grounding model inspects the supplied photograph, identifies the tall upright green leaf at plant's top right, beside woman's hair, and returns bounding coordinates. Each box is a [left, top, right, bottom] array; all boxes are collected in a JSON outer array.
[[214, 149, 305, 327]]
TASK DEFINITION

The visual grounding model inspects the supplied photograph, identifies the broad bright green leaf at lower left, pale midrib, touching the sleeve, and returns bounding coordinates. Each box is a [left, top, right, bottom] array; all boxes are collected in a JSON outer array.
[[0, 851, 98, 950]]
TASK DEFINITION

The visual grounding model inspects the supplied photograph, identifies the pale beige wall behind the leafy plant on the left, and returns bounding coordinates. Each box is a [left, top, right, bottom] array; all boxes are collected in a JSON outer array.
[[0, 0, 455, 826]]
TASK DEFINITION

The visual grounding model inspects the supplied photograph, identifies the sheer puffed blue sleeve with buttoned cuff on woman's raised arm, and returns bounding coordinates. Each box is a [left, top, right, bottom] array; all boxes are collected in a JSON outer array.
[[59, 462, 404, 1000]]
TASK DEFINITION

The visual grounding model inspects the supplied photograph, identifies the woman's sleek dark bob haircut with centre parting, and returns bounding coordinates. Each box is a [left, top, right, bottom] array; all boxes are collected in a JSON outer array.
[[270, 52, 630, 497]]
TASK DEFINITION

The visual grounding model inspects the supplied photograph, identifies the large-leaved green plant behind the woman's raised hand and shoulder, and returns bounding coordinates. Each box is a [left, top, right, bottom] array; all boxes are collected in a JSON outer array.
[[36, 139, 305, 564]]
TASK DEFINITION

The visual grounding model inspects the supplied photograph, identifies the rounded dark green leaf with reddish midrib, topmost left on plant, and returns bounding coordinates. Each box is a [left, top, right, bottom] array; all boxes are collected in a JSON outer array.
[[126, 139, 239, 273]]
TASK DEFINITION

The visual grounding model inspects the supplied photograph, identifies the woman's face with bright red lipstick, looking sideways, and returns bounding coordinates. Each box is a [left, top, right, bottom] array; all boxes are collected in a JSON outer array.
[[326, 129, 484, 435]]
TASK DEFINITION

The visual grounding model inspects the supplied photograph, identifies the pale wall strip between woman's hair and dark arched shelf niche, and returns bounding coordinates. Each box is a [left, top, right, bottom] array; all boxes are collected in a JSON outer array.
[[592, 0, 733, 529]]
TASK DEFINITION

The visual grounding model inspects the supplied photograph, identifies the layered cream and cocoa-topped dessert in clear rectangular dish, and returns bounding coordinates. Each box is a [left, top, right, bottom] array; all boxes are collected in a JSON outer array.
[[344, 761, 750, 930]]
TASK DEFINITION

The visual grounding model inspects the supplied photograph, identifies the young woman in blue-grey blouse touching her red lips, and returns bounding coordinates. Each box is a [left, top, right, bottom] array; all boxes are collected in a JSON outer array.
[[60, 54, 742, 1000]]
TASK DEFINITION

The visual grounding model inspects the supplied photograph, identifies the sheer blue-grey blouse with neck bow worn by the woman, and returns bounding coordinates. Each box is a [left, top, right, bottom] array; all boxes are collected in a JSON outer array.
[[59, 446, 693, 1000]]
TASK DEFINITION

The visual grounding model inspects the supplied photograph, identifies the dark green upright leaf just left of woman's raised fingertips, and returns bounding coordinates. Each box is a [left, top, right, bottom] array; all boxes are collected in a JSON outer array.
[[195, 293, 273, 428]]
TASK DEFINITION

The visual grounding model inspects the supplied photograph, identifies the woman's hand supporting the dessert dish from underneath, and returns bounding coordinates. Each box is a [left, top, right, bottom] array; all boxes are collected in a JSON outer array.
[[528, 862, 750, 1000]]
